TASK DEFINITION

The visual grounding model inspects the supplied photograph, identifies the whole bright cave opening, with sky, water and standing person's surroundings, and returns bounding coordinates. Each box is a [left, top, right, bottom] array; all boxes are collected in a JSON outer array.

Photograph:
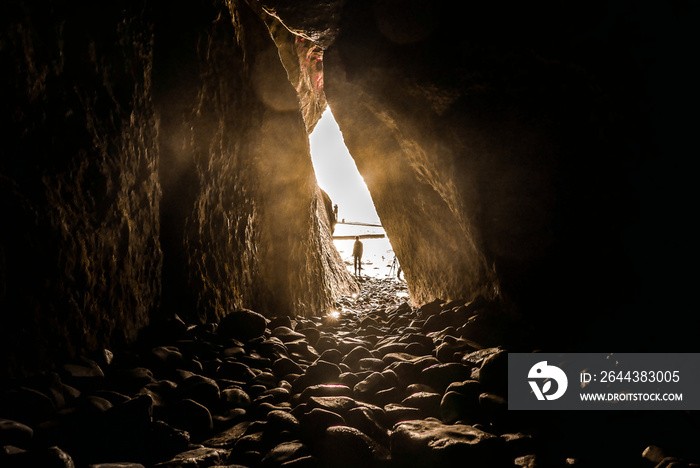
[[309, 107, 398, 278]]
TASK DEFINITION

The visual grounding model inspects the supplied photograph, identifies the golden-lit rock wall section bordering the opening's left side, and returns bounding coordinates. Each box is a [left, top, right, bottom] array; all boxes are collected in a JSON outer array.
[[154, 2, 349, 321]]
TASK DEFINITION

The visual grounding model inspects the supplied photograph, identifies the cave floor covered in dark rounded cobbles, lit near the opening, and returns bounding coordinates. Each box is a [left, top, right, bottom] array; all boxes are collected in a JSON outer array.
[[0, 278, 698, 468]]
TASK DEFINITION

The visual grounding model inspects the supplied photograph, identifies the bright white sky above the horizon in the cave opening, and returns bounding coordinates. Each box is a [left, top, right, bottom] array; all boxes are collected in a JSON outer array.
[[309, 107, 379, 223]]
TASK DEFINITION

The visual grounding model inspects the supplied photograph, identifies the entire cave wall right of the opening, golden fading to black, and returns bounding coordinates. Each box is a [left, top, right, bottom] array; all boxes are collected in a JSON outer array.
[[264, 0, 698, 349]]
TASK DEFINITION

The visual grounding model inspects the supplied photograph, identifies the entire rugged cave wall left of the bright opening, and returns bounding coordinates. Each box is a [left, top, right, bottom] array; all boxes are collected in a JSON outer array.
[[0, 1, 353, 374]]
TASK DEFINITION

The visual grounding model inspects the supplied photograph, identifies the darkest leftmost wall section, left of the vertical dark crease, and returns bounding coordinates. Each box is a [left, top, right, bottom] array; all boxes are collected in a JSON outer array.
[[0, 2, 161, 373]]
